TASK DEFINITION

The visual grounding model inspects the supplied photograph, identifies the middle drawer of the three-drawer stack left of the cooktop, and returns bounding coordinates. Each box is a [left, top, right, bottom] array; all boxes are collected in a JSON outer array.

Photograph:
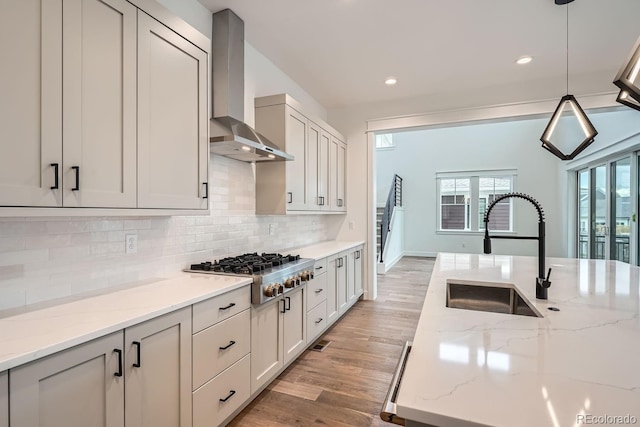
[[193, 310, 251, 390]]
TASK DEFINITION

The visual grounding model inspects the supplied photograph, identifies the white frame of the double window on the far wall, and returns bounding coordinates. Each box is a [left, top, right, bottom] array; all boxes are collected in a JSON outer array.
[[435, 169, 518, 235]]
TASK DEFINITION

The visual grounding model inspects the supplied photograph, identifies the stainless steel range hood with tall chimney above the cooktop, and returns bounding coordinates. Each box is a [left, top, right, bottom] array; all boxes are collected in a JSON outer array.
[[209, 9, 293, 162]]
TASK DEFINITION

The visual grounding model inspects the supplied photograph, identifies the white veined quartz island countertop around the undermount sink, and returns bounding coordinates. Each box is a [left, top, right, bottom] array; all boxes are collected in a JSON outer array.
[[397, 253, 640, 427]]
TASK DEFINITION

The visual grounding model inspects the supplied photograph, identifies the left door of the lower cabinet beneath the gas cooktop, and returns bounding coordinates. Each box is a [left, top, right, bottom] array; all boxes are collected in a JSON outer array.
[[251, 299, 285, 394]]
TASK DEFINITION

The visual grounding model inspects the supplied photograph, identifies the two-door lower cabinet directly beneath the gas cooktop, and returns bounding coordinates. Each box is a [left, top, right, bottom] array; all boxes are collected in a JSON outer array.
[[251, 287, 307, 393]]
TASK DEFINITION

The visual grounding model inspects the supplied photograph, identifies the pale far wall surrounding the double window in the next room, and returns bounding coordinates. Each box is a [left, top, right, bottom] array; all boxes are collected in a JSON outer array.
[[376, 119, 563, 256]]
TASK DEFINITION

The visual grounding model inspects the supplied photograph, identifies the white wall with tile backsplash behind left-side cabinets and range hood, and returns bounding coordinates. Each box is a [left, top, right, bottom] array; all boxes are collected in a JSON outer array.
[[0, 0, 339, 310]]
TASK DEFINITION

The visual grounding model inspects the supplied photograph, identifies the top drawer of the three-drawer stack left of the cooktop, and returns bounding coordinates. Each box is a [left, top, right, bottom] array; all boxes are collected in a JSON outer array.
[[193, 285, 251, 334]]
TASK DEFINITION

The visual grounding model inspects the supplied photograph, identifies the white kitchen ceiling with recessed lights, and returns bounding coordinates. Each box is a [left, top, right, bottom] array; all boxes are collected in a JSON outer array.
[[199, 0, 640, 108]]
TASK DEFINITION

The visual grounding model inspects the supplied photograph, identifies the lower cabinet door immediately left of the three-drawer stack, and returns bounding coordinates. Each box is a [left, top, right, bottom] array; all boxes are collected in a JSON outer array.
[[125, 307, 192, 427]]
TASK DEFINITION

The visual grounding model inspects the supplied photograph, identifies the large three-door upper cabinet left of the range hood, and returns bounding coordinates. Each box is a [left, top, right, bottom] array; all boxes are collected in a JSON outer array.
[[0, 0, 210, 216]]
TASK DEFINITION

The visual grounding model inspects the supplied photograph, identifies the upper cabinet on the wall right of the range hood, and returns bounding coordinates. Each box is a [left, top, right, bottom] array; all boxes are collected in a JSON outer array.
[[255, 95, 346, 214]]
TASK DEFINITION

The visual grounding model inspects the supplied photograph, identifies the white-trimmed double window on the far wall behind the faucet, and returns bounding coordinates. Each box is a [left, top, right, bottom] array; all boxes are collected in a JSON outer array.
[[436, 170, 516, 231]]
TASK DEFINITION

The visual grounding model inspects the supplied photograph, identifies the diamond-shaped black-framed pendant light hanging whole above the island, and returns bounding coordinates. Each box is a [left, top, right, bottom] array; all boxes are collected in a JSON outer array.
[[540, 0, 598, 160]]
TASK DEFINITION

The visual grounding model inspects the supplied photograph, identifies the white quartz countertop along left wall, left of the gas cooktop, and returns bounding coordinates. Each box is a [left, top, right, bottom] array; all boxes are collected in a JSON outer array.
[[0, 273, 251, 372]]
